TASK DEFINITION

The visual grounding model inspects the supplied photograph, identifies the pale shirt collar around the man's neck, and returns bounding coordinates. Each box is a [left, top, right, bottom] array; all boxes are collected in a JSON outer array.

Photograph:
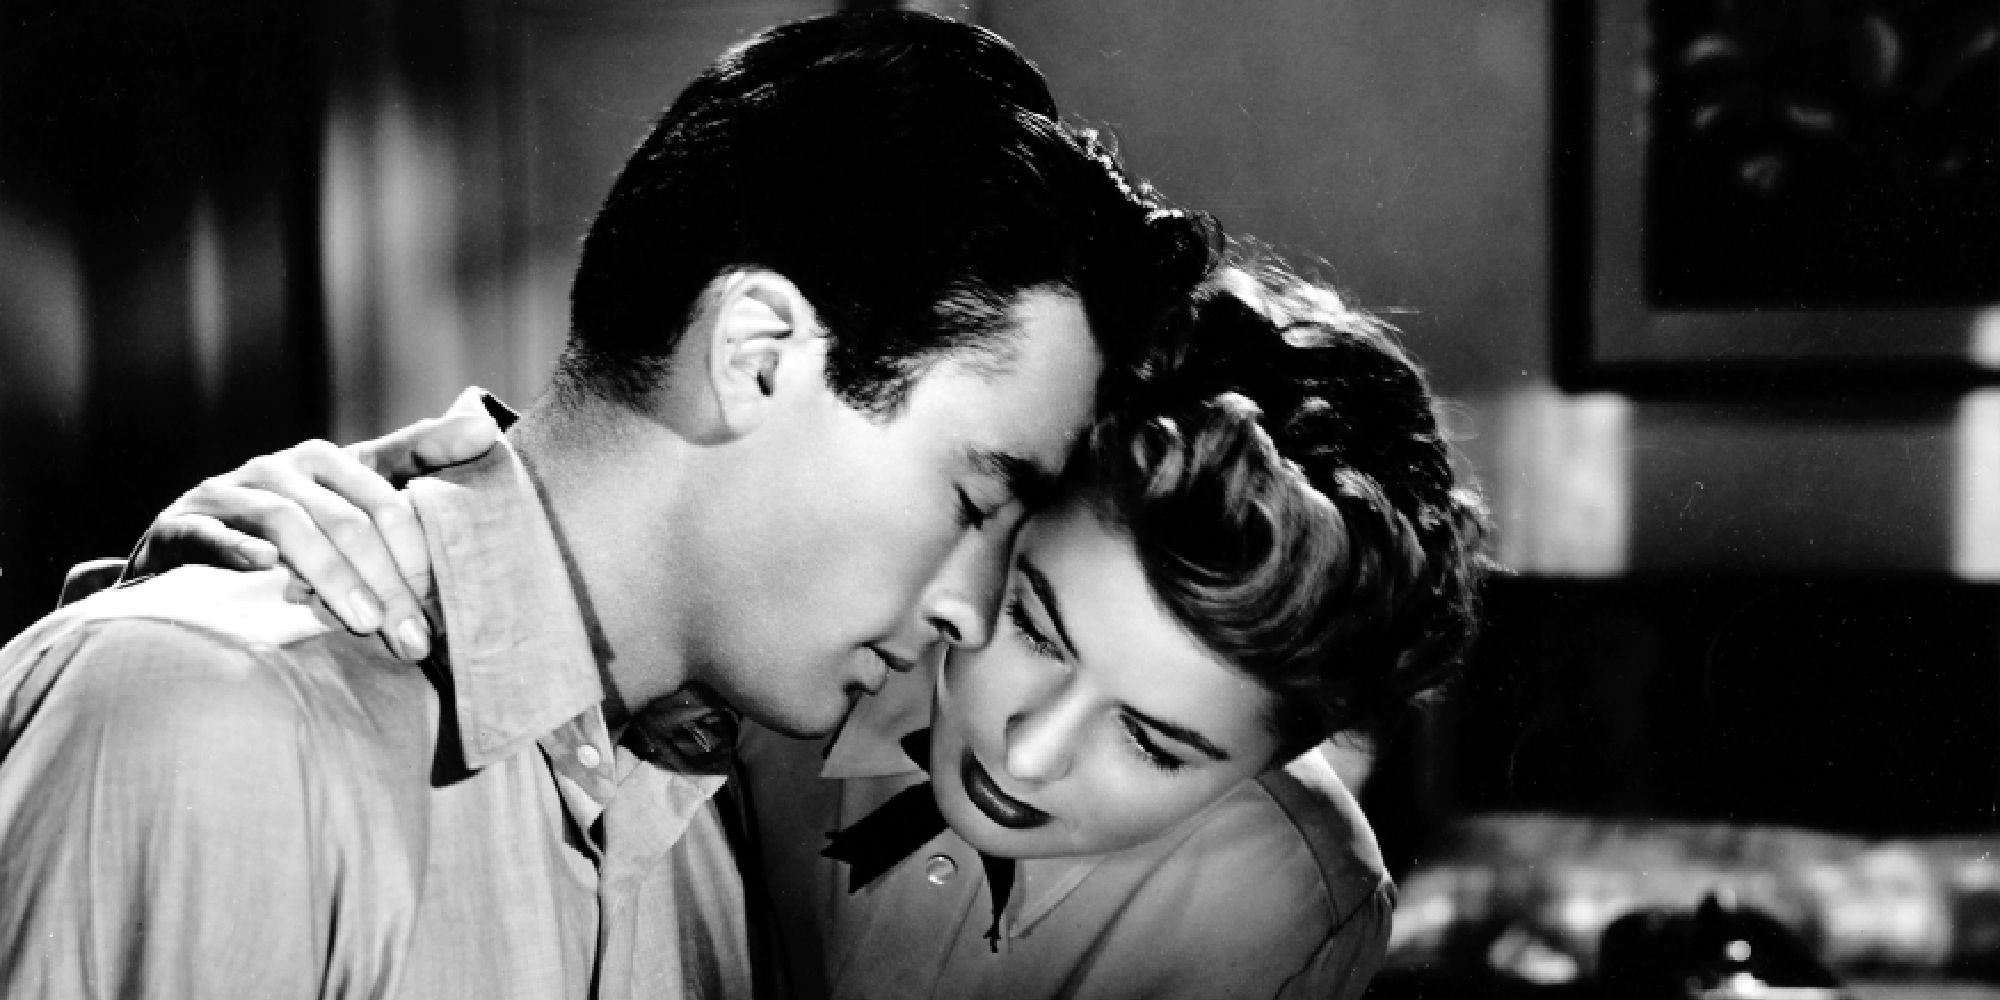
[[410, 426, 604, 770]]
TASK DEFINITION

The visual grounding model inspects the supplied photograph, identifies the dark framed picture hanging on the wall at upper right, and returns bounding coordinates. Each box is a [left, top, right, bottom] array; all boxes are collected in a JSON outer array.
[[1552, 0, 2000, 394]]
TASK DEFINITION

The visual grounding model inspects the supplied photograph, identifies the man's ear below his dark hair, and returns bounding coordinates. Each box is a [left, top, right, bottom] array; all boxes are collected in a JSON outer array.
[[706, 270, 826, 436]]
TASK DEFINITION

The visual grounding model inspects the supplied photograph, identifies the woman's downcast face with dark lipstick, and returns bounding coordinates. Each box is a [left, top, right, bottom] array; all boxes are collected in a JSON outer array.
[[930, 502, 1276, 858]]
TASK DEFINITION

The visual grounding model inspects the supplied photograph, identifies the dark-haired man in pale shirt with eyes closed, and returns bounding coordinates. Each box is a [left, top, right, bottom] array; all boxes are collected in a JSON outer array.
[[0, 12, 1210, 998]]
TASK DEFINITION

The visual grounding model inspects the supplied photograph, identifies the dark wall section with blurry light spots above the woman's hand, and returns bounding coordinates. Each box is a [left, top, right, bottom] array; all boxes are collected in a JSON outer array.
[[0, 0, 328, 636]]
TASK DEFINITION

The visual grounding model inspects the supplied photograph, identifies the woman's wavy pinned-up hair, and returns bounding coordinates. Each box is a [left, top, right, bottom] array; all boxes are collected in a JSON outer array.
[[1072, 248, 1488, 760]]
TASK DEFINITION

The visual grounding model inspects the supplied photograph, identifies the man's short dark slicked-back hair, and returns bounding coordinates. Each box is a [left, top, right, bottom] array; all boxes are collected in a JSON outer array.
[[558, 10, 1216, 414]]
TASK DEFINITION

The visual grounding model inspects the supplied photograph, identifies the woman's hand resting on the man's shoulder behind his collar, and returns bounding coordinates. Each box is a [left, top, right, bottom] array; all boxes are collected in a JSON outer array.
[[126, 388, 500, 660]]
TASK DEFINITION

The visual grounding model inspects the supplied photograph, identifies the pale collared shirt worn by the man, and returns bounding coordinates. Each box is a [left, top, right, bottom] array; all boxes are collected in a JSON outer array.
[[0, 434, 750, 1000]]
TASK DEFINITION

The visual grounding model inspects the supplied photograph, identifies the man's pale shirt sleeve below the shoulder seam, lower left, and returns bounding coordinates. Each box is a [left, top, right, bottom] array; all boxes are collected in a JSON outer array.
[[0, 622, 338, 1000]]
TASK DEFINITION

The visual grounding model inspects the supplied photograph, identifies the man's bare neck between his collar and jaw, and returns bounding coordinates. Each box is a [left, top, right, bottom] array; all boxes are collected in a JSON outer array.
[[508, 402, 690, 738]]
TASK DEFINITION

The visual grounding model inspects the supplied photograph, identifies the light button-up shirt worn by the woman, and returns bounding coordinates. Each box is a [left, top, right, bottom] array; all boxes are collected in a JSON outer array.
[[738, 656, 1396, 1000]]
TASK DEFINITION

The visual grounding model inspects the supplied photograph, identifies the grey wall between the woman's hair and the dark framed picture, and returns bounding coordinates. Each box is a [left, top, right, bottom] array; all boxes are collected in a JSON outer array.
[[984, 0, 1996, 578]]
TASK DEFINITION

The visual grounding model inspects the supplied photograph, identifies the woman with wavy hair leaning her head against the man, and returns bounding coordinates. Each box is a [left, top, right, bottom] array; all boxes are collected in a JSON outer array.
[[105, 262, 1484, 998]]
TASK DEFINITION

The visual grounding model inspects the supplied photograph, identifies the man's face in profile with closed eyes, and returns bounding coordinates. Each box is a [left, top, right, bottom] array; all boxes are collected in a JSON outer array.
[[692, 292, 1102, 736]]
